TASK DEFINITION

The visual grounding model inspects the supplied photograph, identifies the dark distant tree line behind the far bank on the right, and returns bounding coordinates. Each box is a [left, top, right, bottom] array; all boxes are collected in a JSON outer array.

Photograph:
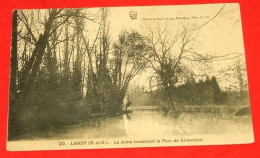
[[129, 76, 249, 106]]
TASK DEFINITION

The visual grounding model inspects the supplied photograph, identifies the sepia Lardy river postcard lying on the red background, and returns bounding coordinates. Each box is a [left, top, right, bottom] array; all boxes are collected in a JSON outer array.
[[7, 3, 254, 151]]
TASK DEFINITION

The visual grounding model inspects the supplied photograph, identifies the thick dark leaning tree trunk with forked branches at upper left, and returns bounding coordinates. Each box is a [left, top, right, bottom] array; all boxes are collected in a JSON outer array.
[[19, 9, 76, 92]]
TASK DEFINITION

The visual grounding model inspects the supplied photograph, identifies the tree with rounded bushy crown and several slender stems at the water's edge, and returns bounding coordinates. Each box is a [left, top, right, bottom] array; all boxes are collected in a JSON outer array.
[[111, 31, 150, 112]]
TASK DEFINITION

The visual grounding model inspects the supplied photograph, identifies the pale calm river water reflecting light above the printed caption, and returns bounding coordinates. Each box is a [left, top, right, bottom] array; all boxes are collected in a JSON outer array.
[[21, 111, 252, 139]]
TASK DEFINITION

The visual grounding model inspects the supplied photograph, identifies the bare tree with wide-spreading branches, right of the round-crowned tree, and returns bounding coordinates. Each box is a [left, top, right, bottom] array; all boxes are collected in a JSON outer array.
[[143, 25, 201, 110]]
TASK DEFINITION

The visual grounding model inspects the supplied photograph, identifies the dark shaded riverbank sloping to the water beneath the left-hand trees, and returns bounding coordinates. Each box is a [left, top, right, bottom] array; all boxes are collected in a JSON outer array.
[[8, 106, 132, 140]]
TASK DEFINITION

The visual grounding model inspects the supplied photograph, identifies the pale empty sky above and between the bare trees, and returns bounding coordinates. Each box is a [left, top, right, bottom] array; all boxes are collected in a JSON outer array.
[[93, 3, 245, 89]]
